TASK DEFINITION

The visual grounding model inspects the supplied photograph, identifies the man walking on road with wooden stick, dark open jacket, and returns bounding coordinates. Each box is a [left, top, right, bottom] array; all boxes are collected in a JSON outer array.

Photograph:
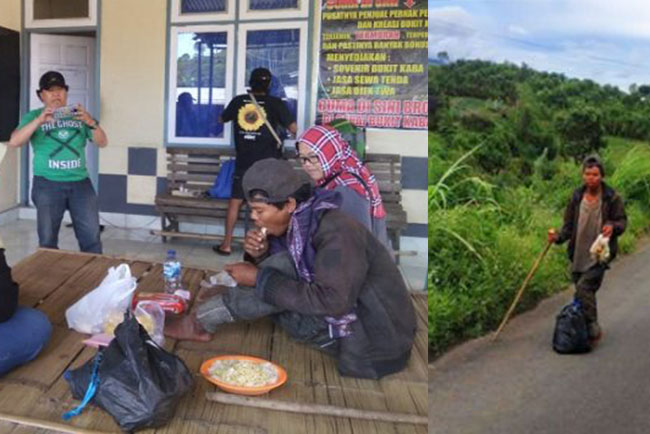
[[548, 156, 627, 341]]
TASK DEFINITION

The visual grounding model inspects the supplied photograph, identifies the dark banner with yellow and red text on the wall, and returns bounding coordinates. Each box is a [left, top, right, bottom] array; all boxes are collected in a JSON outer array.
[[317, 0, 429, 129]]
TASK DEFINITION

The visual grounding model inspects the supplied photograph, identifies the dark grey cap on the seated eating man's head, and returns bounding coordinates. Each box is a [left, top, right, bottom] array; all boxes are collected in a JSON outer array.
[[242, 158, 309, 203]]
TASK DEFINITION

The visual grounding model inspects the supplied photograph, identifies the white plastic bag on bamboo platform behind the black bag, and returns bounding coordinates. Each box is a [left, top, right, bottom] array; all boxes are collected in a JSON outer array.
[[65, 264, 136, 334]]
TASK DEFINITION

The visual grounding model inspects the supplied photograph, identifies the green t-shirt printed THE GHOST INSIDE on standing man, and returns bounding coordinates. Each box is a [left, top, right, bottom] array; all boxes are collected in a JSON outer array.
[[18, 108, 92, 181]]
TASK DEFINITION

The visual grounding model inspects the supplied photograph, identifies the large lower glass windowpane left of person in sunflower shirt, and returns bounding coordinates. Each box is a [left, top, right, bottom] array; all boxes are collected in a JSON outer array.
[[170, 29, 232, 143]]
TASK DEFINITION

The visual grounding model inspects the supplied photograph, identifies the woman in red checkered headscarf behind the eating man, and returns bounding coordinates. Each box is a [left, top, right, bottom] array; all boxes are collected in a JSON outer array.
[[297, 125, 392, 252]]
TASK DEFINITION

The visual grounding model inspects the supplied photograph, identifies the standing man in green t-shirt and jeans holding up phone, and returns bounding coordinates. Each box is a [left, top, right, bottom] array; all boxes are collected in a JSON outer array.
[[8, 71, 108, 253]]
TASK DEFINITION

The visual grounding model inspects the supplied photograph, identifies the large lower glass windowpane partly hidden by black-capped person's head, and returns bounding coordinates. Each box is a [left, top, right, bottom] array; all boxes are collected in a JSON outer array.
[[245, 29, 300, 124]]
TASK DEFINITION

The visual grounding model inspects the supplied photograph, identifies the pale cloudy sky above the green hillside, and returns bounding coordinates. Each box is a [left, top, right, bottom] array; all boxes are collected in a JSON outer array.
[[429, 0, 650, 90]]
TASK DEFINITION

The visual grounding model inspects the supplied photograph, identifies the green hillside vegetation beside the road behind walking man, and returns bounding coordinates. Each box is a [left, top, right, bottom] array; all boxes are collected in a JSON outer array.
[[429, 61, 650, 356]]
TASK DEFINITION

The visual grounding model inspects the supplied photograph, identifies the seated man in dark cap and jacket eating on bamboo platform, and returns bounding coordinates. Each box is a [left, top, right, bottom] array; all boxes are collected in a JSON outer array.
[[165, 158, 415, 378]]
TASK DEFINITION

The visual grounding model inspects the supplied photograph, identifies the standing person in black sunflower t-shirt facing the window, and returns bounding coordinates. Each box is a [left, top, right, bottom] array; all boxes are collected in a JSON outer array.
[[212, 68, 297, 256]]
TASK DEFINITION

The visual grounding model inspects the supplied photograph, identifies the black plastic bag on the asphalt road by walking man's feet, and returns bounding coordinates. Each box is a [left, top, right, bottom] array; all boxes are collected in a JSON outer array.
[[553, 300, 591, 354]]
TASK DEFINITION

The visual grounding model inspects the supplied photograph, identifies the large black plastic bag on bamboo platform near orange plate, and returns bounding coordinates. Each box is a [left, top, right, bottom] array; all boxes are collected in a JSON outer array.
[[65, 315, 193, 431]]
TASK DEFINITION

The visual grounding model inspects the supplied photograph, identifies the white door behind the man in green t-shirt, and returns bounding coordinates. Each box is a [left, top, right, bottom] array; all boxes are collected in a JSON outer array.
[[29, 33, 98, 204]]
